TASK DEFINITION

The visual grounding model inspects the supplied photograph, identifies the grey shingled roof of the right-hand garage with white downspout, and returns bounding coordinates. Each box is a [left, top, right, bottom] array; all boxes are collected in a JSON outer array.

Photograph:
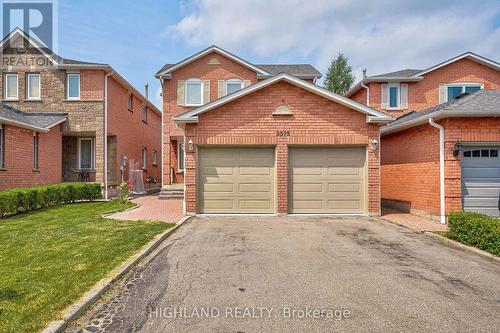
[[380, 89, 500, 135]]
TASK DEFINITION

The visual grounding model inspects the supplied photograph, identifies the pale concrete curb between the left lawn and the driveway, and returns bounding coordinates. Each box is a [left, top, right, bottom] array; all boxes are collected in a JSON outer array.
[[42, 214, 192, 333]]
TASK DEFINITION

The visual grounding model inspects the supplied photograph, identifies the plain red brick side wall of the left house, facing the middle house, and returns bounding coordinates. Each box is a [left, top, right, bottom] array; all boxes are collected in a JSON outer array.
[[108, 78, 161, 186]]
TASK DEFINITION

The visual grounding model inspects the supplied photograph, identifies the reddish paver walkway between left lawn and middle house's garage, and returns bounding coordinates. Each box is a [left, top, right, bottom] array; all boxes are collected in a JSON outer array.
[[109, 195, 184, 223]]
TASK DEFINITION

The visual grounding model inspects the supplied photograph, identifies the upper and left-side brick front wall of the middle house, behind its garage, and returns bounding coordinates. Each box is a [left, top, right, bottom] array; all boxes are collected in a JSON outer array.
[[163, 52, 257, 184]]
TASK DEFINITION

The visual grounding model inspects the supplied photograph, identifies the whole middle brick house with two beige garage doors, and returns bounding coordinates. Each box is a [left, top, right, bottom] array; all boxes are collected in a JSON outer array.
[[157, 46, 393, 215]]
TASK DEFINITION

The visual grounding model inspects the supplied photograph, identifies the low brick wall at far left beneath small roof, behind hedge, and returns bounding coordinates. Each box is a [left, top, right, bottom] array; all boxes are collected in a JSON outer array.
[[0, 125, 62, 190]]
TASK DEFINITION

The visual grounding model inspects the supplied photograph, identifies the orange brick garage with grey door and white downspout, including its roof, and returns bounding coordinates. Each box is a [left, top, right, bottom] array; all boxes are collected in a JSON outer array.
[[381, 89, 500, 223]]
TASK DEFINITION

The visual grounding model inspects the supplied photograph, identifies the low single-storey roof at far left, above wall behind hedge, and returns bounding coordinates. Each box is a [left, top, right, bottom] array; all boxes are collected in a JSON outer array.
[[0, 103, 68, 132]]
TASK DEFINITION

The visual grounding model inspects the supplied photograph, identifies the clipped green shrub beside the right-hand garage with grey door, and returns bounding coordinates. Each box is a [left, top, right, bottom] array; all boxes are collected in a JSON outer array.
[[447, 212, 500, 256]]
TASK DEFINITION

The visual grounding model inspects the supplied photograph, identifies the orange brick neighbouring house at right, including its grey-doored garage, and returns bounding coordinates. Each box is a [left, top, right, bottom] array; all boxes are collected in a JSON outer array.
[[346, 52, 500, 219]]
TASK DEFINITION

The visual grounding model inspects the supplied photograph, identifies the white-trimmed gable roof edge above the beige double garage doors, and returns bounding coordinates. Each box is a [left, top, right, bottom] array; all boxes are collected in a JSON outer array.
[[173, 73, 394, 123]]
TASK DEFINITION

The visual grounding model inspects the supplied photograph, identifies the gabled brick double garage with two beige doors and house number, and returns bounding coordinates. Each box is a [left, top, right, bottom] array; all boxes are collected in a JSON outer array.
[[173, 73, 392, 215]]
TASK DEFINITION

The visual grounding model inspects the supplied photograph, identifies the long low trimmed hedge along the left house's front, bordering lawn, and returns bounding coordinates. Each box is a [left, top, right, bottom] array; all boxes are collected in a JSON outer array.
[[0, 183, 101, 217]]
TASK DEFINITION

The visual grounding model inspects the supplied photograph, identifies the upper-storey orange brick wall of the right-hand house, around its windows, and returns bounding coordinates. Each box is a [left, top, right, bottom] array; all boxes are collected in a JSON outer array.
[[351, 59, 500, 117]]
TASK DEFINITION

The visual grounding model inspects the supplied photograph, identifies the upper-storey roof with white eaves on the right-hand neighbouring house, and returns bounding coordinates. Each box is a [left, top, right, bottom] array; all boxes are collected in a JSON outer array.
[[344, 52, 500, 97]]
